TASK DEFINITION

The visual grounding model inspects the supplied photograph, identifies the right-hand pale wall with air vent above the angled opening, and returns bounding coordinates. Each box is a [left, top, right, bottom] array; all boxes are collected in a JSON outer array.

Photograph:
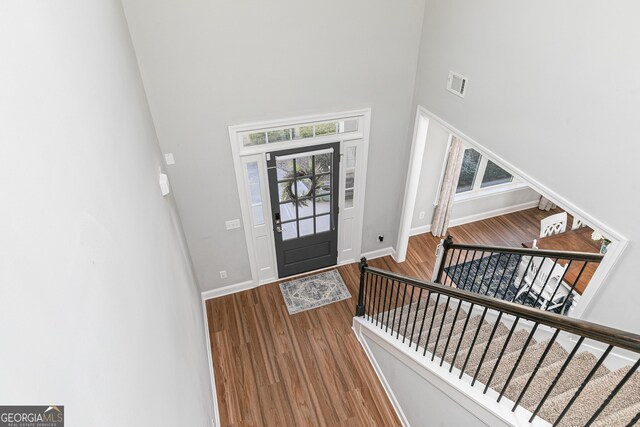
[[414, 0, 640, 332]]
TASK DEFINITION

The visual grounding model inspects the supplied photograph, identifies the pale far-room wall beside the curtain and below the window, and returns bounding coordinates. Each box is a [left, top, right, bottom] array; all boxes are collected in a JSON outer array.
[[411, 120, 540, 233]]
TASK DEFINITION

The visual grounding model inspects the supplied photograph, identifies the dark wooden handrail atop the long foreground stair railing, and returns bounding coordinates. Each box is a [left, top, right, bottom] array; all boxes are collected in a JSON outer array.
[[361, 268, 640, 353]]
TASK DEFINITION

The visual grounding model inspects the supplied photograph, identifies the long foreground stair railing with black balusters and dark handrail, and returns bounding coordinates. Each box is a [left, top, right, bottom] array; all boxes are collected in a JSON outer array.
[[356, 258, 640, 426]]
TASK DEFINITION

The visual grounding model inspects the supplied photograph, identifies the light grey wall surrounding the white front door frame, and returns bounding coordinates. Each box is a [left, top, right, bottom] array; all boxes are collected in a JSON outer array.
[[123, 0, 424, 290]]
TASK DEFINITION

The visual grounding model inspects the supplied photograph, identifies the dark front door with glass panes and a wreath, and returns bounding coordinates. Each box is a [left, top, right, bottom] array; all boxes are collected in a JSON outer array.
[[267, 143, 340, 277]]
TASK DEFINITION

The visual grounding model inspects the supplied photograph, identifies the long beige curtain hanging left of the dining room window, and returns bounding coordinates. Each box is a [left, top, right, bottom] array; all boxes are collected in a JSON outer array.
[[431, 136, 464, 237]]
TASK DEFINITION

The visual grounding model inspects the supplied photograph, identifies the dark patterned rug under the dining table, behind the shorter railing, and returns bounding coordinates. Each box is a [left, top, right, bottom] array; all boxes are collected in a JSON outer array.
[[444, 254, 574, 314]]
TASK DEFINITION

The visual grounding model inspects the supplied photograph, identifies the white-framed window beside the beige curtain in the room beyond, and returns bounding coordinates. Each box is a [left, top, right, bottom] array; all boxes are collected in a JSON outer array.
[[456, 148, 513, 194]]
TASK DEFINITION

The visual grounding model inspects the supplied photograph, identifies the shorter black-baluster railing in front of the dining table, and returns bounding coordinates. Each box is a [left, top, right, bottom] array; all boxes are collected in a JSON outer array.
[[434, 236, 604, 314]]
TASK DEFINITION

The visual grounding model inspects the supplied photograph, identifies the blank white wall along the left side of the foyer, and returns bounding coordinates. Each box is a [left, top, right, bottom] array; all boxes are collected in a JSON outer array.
[[0, 0, 212, 427]]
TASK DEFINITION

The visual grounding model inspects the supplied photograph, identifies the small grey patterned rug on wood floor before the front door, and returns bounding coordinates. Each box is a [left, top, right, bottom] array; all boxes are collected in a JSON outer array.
[[280, 270, 351, 314]]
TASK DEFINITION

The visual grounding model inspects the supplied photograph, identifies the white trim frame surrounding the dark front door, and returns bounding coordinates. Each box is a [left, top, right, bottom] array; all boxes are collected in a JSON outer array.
[[228, 108, 371, 288]]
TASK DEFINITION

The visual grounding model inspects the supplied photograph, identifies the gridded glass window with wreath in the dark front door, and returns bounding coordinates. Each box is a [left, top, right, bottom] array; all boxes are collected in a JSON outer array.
[[276, 153, 333, 241]]
